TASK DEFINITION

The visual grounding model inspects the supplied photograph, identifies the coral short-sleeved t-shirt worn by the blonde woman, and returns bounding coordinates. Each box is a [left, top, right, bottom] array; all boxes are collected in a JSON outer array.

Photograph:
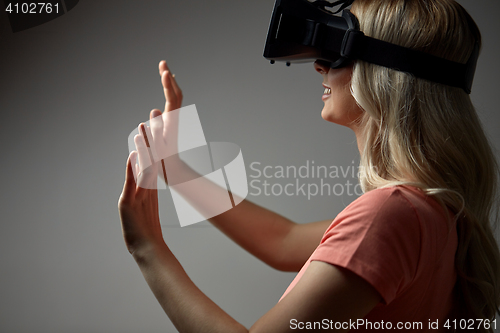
[[282, 186, 457, 332]]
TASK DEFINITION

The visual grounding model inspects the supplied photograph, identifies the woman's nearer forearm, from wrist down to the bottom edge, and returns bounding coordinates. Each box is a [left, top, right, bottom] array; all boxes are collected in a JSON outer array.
[[134, 245, 248, 333]]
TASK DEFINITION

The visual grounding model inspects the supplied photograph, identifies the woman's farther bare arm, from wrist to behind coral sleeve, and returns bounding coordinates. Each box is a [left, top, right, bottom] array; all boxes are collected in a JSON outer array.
[[167, 160, 331, 271]]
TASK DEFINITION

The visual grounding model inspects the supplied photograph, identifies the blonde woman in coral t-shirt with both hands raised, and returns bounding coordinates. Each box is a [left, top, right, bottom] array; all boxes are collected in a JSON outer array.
[[119, 0, 500, 332]]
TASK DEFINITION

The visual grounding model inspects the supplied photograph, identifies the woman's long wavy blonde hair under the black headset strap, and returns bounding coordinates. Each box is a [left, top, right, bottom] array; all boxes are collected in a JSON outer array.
[[351, 0, 500, 326]]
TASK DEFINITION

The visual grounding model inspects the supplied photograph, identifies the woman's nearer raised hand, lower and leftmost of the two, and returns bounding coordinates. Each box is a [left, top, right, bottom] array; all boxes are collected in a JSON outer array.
[[118, 124, 165, 256]]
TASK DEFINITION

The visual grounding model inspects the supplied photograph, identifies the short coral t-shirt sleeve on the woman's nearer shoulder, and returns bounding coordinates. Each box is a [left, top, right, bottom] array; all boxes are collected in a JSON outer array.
[[311, 188, 421, 304]]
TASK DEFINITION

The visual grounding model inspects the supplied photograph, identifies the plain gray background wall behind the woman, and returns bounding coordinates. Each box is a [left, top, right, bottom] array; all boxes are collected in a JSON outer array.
[[0, 0, 500, 333]]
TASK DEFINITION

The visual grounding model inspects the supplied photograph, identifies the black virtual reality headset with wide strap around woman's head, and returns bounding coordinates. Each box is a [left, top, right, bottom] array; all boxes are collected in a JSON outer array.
[[264, 0, 479, 94]]
